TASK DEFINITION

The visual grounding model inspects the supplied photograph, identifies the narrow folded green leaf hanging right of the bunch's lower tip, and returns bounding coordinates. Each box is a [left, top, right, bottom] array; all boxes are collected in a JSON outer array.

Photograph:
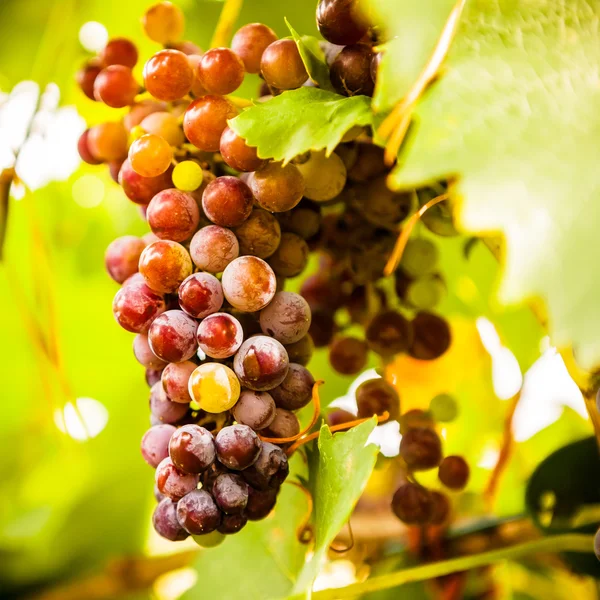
[[294, 418, 379, 593]]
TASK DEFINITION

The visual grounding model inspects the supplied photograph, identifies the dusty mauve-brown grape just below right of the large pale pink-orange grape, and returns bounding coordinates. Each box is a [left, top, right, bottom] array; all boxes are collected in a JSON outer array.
[[260, 292, 311, 344]]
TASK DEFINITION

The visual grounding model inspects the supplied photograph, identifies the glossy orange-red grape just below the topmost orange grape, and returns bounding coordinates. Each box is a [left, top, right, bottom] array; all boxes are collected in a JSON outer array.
[[144, 50, 194, 102]]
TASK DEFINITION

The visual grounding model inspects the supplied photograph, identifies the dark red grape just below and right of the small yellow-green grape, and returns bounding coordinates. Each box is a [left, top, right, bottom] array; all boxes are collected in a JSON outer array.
[[202, 175, 254, 227]]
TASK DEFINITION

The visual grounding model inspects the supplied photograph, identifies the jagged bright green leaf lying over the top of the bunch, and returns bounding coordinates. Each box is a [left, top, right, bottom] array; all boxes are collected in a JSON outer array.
[[229, 87, 373, 162]]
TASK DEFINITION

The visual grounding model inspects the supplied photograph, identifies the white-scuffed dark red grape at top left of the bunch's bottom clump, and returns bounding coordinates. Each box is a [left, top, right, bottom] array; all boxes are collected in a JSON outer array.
[[168, 425, 216, 474]]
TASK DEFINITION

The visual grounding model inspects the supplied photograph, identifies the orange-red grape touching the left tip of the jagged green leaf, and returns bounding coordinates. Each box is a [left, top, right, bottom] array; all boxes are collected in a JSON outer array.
[[183, 94, 238, 152]]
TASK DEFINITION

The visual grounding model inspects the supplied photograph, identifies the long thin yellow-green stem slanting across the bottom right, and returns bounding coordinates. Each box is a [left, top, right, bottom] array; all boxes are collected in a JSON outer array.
[[289, 533, 594, 600]]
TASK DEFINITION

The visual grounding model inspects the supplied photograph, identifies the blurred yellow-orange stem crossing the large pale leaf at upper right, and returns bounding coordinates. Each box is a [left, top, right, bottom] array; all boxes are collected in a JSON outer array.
[[378, 0, 466, 166]]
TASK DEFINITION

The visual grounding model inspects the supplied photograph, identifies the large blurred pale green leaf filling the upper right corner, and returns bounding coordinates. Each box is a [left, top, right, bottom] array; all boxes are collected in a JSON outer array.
[[372, 0, 600, 367]]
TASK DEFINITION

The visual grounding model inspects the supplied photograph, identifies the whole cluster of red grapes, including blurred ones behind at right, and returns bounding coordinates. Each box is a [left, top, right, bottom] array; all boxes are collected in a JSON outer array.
[[78, 0, 468, 544]]
